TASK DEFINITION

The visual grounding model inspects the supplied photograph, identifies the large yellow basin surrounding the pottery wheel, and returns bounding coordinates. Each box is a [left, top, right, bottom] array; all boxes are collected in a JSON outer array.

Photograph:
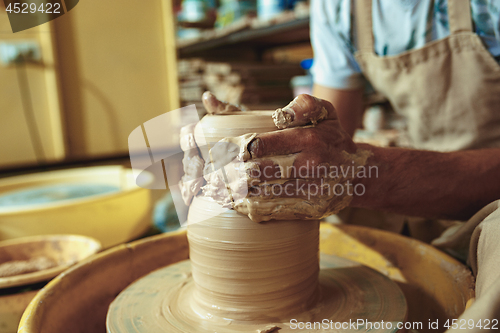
[[18, 221, 474, 333]]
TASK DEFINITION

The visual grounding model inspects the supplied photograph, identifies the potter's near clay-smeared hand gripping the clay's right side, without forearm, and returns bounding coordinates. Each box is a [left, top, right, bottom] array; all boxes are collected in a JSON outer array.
[[229, 95, 370, 222]]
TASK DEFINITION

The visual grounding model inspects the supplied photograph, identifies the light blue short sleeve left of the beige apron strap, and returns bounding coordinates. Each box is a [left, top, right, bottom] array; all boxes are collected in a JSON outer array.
[[310, 0, 365, 89]]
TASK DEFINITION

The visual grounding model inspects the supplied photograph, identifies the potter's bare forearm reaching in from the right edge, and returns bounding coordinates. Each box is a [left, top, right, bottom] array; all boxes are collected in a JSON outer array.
[[351, 145, 500, 220]]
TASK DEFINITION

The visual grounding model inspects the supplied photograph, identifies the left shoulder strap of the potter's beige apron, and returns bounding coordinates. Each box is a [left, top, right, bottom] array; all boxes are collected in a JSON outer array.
[[352, 0, 374, 52]]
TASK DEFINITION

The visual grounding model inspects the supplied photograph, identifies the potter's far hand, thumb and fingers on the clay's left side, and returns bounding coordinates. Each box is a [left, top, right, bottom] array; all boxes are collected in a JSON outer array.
[[179, 91, 240, 205]]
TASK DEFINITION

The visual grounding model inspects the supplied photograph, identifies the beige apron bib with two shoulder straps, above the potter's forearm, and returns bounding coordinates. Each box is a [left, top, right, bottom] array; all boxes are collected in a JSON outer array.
[[354, 0, 500, 151]]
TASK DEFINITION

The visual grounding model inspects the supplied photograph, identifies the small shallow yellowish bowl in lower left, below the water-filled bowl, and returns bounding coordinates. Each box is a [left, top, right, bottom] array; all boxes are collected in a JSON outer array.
[[0, 235, 101, 333]]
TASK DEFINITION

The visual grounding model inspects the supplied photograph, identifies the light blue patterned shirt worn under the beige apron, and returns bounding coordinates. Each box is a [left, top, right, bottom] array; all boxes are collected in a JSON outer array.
[[311, 0, 500, 89]]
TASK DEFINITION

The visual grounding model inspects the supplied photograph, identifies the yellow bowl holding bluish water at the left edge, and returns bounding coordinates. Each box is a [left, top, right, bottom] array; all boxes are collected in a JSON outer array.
[[0, 166, 151, 248]]
